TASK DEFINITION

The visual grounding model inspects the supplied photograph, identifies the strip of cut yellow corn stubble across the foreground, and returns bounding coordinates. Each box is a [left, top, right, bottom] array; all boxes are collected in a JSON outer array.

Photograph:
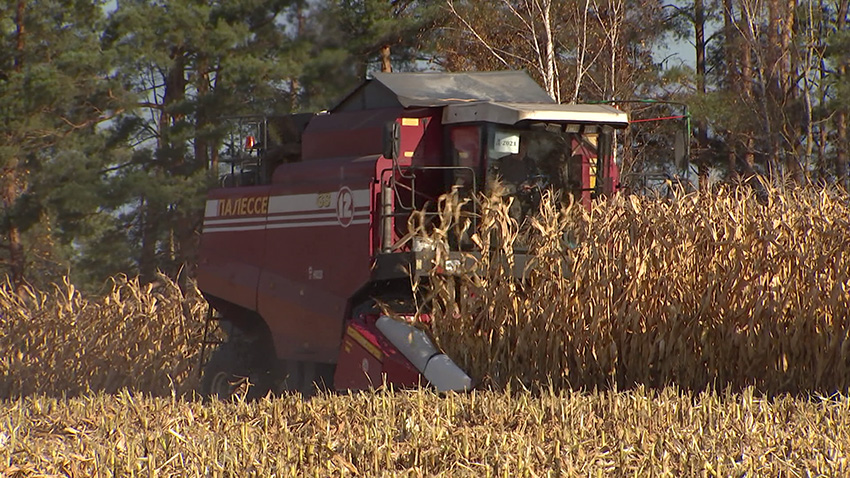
[[0, 388, 850, 478]]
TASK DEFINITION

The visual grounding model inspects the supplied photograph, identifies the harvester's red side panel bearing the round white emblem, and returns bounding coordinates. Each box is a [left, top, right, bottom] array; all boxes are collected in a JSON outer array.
[[257, 156, 377, 363]]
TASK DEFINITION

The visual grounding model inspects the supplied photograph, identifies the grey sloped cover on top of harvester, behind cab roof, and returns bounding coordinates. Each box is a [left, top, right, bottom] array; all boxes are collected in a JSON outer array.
[[331, 71, 555, 112]]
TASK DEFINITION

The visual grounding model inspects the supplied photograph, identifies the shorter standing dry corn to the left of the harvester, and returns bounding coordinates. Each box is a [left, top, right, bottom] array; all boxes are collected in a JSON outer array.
[[0, 276, 206, 398]]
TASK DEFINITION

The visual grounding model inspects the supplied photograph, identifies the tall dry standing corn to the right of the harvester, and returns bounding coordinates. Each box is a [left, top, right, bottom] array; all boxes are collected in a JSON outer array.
[[420, 188, 850, 393]]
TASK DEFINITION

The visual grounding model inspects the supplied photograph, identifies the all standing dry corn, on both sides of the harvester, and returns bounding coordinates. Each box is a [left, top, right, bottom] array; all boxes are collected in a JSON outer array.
[[0, 189, 850, 397]]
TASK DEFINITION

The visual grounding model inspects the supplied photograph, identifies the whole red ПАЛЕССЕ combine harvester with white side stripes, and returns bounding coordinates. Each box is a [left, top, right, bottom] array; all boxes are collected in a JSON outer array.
[[197, 72, 628, 397]]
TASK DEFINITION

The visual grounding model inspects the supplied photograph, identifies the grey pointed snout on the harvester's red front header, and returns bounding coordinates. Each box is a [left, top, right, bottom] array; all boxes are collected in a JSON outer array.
[[375, 315, 472, 392]]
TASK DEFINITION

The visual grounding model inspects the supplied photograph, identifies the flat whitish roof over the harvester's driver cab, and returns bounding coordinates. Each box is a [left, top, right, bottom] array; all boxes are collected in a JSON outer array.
[[443, 101, 629, 128]]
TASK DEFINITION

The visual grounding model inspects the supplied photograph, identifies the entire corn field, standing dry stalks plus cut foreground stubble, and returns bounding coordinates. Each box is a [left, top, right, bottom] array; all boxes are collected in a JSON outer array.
[[0, 184, 850, 477]]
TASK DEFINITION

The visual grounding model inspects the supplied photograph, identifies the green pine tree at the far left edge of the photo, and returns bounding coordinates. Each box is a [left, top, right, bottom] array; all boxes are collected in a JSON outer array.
[[0, 0, 131, 286]]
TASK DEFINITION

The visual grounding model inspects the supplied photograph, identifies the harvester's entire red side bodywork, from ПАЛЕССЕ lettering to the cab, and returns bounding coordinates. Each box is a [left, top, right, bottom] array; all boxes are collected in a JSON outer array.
[[198, 108, 442, 363]]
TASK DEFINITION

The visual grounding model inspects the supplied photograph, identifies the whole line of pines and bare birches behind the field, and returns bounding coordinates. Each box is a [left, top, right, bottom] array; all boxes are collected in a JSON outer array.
[[0, 0, 850, 287]]
